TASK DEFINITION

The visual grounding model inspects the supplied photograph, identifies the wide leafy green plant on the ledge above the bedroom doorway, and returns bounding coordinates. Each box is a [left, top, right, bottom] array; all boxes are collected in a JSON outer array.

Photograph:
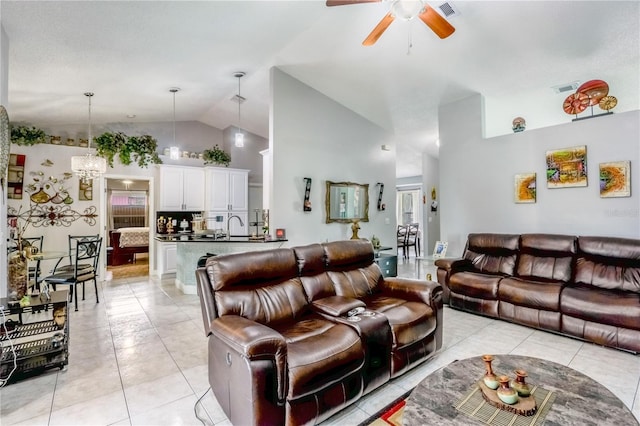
[[93, 132, 162, 167]]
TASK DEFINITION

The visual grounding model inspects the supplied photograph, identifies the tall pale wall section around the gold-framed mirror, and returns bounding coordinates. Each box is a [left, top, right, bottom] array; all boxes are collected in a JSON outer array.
[[269, 68, 396, 247]]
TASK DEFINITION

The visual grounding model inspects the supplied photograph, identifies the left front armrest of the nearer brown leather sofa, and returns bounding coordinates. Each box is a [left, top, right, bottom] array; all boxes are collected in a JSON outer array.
[[211, 315, 287, 401]]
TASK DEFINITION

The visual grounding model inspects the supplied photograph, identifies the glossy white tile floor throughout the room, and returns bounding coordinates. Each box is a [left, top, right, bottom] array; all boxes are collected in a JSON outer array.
[[0, 259, 640, 426]]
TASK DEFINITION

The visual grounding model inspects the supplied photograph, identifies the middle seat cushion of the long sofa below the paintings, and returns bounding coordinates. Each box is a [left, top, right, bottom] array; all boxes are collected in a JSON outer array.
[[498, 277, 563, 311]]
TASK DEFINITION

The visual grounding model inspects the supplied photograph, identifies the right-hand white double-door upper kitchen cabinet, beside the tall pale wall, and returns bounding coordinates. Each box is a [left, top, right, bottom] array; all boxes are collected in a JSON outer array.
[[205, 167, 249, 212]]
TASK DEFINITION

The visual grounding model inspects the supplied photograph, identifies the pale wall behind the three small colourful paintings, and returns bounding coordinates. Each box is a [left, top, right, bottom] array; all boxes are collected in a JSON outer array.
[[439, 95, 640, 255]]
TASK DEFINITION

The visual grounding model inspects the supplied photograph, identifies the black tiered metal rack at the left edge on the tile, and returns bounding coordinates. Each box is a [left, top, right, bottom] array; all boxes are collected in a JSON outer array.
[[0, 290, 69, 383]]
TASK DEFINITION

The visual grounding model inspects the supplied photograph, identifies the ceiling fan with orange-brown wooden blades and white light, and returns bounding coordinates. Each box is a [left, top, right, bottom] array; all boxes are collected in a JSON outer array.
[[327, 0, 456, 46]]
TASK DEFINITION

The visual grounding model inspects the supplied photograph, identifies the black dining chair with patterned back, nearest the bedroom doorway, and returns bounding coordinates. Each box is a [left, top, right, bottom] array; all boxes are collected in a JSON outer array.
[[44, 237, 102, 311]]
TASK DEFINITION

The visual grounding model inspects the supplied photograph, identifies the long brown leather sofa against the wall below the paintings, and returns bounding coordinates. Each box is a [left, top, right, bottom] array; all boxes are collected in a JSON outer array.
[[435, 233, 640, 353]]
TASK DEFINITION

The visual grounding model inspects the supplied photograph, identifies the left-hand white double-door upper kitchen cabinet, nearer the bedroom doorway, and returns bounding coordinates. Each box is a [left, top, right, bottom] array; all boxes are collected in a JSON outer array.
[[158, 166, 205, 211]]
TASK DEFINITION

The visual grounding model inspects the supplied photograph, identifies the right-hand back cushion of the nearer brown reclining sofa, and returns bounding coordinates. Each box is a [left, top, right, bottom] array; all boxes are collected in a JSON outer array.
[[322, 240, 382, 298]]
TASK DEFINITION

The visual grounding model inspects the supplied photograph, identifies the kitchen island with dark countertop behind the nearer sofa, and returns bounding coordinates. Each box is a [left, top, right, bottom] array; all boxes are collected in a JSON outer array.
[[155, 234, 287, 294]]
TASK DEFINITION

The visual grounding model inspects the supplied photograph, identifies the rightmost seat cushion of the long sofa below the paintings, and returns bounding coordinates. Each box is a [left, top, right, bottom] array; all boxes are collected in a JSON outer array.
[[560, 285, 640, 330]]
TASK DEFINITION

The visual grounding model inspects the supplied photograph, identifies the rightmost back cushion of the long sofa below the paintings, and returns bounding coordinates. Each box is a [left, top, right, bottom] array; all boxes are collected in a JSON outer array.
[[575, 237, 640, 293]]
